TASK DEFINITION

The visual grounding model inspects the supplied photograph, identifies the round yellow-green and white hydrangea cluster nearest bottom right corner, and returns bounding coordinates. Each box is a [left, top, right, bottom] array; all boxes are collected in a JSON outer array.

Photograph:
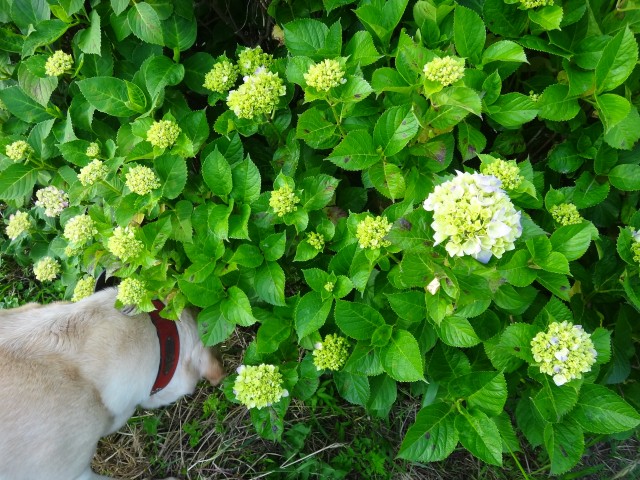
[[531, 321, 598, 386]]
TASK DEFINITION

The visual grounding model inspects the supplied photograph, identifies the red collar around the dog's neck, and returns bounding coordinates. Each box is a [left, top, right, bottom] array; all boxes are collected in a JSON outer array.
[[149, 300, 180, 395]]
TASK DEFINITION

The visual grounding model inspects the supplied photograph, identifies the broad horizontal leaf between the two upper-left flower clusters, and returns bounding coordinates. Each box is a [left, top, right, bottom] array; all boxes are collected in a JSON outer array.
[[77, 77, 146, 117]]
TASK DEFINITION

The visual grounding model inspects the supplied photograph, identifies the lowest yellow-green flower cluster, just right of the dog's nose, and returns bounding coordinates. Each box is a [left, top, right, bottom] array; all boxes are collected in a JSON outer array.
[[233, 363, 289, 410]]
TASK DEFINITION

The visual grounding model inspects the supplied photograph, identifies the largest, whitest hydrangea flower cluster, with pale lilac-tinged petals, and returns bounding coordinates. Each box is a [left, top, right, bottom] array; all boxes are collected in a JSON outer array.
[[423, 172, 522, 263]]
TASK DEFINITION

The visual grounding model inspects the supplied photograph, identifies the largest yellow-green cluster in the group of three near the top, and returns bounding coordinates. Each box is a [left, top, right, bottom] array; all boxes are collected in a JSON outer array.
[[227, 69, 287, 119]]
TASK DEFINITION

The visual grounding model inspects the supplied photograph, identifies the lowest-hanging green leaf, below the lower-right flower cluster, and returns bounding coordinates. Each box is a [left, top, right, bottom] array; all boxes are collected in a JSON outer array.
[[544, 417, 584, 475]]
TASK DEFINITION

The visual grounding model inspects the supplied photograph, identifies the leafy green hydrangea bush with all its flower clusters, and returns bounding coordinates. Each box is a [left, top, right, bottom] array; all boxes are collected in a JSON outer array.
[[0, 0, 640, 474]]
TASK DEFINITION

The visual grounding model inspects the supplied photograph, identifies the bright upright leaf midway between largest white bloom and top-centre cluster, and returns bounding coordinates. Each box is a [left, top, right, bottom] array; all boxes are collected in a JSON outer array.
[[373, 104, 419, 157]]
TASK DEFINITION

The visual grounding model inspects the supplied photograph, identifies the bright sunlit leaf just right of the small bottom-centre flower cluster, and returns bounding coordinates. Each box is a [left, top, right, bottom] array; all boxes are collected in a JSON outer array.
[[381, 329, 424, 382]]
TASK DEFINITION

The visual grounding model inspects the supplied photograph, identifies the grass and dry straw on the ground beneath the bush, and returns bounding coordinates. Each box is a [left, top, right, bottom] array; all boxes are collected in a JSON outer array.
[[0, 257, 640, 480]]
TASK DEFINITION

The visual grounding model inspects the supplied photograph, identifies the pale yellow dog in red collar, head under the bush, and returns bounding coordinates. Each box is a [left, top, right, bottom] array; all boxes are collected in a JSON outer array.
[[0, 288, 224, 480]]
